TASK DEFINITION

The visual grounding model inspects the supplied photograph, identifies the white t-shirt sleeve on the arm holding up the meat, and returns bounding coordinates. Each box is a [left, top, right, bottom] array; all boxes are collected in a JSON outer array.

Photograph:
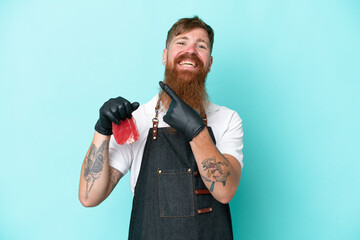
[[109, 136, 133, 175]]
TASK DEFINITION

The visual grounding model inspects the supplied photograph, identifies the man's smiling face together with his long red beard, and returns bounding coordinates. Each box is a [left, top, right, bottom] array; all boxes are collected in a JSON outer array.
[[160, 28, 212, 115]]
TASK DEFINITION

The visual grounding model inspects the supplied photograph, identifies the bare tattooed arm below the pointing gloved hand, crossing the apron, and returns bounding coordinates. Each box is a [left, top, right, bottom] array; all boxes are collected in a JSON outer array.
[[190, 128, 241, 203]]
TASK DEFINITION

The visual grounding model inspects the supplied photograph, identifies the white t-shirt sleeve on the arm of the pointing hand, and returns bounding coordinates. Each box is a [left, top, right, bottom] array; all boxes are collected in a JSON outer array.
[[217, 112, 244, 169]]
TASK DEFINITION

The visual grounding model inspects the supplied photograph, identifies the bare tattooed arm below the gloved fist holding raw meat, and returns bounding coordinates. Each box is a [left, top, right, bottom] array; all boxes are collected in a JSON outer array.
[[79, 131, 123, 207]]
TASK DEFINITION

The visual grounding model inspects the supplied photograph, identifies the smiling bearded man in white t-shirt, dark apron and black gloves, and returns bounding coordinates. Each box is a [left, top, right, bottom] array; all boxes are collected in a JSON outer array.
[[79, 17, 243, 239]]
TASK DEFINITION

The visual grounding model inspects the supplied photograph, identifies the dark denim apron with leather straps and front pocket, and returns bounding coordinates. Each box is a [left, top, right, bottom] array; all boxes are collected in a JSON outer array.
[[129, 108, 233, 240]]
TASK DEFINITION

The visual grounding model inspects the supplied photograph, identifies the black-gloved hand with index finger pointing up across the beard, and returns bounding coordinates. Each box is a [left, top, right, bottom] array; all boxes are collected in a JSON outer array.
[[159, 82, 205, 142]]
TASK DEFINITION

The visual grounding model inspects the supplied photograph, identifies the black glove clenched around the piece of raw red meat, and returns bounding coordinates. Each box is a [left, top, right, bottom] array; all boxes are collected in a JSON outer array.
[[95, 97, 139, 135]]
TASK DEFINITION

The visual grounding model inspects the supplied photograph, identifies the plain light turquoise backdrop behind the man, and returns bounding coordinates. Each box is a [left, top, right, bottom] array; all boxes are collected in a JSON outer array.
[[0, 0, 360, 240]]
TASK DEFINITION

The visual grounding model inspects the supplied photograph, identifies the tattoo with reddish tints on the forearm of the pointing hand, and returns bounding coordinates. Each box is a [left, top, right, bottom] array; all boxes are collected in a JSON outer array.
[[202, 157, 230, 192]]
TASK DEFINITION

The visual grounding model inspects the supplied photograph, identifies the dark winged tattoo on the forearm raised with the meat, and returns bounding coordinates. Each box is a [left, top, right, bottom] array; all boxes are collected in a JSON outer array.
[[84, 140, 107, 200]]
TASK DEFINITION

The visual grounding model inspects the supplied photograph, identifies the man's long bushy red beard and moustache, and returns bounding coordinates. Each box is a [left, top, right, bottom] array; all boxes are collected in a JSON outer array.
[[160, 53, 208, 116]]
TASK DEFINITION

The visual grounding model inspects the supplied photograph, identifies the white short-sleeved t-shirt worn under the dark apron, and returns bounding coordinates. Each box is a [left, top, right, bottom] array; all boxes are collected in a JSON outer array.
[[109, 95, 244, 194]]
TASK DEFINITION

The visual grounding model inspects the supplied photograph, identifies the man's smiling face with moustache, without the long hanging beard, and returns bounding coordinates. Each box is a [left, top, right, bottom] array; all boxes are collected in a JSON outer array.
[[163, 28, 213, 75]]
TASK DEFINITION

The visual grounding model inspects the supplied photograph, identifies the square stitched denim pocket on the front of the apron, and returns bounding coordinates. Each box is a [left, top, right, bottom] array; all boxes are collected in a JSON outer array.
[[158, 168, 195, 217]]
